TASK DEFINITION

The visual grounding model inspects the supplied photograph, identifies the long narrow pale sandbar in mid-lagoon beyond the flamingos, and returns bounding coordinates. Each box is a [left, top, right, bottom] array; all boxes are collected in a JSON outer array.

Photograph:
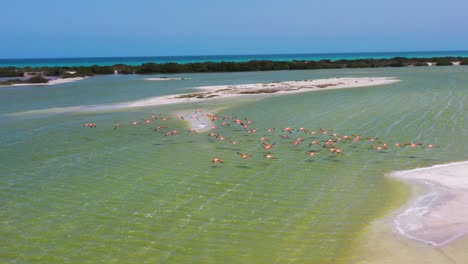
[[121, 77, 399, 107]]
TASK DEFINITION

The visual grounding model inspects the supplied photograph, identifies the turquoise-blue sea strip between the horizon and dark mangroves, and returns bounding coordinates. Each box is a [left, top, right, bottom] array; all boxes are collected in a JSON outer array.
[[0, 51, 468, 67]]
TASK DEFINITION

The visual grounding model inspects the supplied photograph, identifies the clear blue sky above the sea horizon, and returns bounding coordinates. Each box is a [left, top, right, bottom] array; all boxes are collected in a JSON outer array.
[[0, 0, 468, 59]]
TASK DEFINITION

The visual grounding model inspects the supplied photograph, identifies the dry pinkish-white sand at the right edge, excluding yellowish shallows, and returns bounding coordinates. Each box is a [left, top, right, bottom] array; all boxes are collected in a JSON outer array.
[[390, 161, 468, 247]]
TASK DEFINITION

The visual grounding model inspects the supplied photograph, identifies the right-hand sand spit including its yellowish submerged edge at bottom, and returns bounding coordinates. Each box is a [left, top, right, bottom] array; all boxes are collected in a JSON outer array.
[[359, 161, 468, 264]]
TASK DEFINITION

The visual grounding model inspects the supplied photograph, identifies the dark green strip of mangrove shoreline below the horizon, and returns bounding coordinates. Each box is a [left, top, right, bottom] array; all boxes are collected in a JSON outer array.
[[0, 56, 468, 78]]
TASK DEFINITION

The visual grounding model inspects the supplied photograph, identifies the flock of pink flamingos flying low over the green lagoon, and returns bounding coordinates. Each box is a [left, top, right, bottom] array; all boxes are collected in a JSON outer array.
[[84, 110, 438, 164]]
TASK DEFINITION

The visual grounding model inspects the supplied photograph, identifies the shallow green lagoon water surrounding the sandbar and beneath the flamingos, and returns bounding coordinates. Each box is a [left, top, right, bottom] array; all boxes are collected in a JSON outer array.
[[0, 66, 468, 263]]
